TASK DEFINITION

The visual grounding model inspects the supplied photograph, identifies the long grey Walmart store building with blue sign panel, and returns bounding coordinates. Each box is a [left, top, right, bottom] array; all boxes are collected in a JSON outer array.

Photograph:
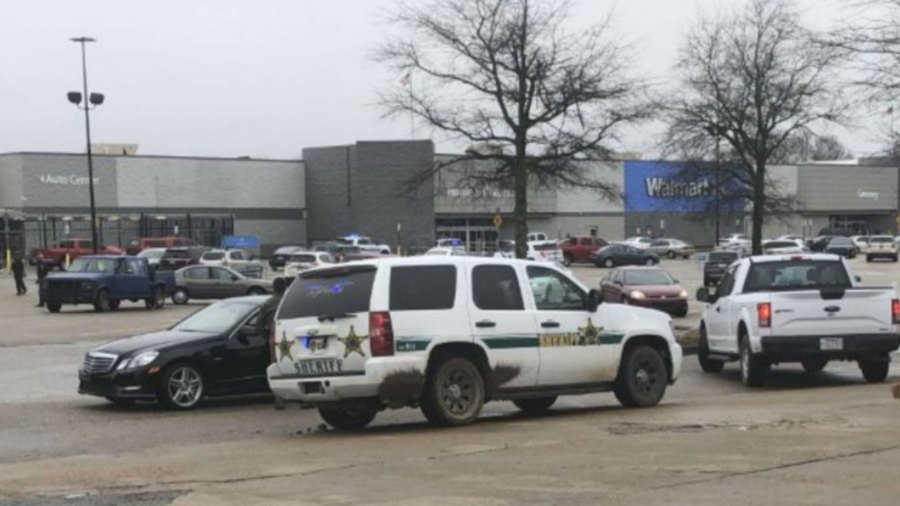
[[0, 141, 898, 254]]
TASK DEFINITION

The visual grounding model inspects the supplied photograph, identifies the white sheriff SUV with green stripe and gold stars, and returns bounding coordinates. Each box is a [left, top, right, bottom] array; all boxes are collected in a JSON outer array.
[[267, 256, 682, 430]]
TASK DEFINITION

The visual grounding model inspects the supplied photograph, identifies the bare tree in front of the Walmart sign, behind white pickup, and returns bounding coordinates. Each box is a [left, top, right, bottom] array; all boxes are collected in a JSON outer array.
[[666, 0, 845, 253]]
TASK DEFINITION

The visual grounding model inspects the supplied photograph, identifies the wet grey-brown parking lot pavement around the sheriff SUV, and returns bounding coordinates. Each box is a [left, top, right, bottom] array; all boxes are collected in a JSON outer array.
[[0, 259, 900, 505]]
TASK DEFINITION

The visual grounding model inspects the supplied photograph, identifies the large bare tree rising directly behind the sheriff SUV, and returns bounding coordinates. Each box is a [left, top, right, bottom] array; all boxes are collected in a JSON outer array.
[[376, 0, 649, 258]]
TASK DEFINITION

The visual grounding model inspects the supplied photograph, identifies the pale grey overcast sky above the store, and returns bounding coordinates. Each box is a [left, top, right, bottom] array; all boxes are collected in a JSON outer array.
[[0, 0, 879, 158]]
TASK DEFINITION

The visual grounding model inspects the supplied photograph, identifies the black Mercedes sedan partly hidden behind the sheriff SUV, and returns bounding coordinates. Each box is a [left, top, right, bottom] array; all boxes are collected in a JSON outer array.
[[78, 296, 276, 409]]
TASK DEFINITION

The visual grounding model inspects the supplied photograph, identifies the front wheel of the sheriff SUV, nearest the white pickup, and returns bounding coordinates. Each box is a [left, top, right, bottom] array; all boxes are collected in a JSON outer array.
[[613, 345, 669, 408]]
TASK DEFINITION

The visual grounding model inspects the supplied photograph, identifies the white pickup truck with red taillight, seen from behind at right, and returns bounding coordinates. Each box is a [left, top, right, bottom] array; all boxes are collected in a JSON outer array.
[[697, 254, 900, 387]]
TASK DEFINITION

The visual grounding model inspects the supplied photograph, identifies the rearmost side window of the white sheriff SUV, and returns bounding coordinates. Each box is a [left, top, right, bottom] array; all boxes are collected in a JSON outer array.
[[390, 265, 456, 311]]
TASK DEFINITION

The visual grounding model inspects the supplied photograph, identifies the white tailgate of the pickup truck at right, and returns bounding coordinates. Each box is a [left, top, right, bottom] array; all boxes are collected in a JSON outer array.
[[770, 288, 894, 336]]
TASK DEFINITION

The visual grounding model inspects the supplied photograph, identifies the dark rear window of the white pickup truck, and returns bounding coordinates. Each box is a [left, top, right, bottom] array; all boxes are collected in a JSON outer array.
[[744, 260, 852, 293]]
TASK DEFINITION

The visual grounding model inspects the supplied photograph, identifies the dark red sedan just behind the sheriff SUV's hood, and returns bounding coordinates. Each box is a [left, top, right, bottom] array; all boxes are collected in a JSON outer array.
[[600, 267, 688, 318]]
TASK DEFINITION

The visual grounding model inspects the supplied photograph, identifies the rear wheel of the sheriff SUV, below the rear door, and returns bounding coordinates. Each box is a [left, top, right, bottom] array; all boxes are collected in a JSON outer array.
[[422, 358, 484, 426]]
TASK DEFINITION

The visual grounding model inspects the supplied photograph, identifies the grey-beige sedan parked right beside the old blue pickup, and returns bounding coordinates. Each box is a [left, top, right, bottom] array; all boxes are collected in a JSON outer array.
[[172, 265, 272, 304]]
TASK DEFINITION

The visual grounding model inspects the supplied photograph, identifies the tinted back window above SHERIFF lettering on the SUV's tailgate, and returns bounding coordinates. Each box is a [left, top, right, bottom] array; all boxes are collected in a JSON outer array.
[[277, 266, 376, 320]]
